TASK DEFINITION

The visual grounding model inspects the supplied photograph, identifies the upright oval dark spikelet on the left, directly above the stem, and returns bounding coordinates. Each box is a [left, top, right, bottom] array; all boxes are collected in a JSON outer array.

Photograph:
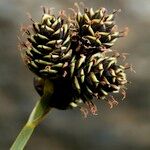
[[21, 8, 72, 79]]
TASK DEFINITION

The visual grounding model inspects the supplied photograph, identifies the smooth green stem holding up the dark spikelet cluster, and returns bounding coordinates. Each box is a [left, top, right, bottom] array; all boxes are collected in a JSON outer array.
[[10, 80, 54, 150]]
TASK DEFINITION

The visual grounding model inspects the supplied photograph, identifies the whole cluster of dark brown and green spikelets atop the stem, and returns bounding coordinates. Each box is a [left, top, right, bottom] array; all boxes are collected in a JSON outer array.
[[20, 3, 128, 114]]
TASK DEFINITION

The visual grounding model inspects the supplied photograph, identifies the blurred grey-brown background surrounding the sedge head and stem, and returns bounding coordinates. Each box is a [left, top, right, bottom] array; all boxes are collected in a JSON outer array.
[[0, 0, 150, 150]]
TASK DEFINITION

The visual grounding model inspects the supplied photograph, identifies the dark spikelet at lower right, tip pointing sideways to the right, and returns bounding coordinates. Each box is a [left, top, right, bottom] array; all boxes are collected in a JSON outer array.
[[70, 52, 127, 108]]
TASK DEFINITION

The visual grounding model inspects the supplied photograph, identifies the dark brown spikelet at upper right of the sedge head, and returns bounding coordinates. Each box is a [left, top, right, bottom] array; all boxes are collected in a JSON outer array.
[[71, 8, 126, 55]]
